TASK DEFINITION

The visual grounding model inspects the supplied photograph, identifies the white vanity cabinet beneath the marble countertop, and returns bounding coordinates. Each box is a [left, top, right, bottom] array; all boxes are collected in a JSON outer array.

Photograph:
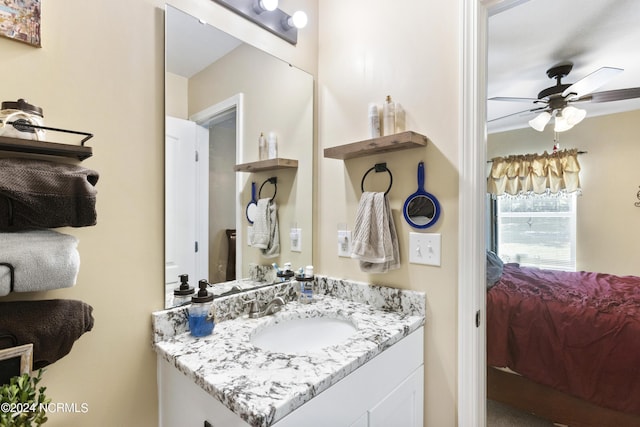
[[158, 327, 424, 427]]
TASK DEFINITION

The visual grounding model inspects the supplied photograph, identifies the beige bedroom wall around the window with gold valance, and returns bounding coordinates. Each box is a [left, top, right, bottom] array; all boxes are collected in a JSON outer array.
[[487, 111, 640, 275]]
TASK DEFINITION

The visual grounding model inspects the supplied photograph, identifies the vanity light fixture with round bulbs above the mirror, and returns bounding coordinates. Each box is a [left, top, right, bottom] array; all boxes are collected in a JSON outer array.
[[213, 0, 307, 45]]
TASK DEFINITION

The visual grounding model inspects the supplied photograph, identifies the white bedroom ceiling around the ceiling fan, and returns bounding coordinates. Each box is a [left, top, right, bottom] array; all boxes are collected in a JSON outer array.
[[487, 0, 640, 133]]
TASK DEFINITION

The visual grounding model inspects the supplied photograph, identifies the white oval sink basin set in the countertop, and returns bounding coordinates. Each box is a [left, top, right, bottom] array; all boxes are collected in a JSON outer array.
[[250, 317, 357, 354]]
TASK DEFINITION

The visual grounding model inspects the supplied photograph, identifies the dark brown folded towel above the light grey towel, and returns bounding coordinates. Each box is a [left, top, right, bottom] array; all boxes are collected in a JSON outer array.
[[0, 158, 99, 231]]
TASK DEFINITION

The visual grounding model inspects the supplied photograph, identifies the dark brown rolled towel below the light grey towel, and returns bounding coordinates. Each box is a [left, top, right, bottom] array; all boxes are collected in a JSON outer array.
[[0, 299, 93, 369]]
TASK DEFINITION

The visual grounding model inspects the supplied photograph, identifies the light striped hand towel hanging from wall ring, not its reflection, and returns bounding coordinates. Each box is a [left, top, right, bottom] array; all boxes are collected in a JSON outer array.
[[351, 192, 400, 273]]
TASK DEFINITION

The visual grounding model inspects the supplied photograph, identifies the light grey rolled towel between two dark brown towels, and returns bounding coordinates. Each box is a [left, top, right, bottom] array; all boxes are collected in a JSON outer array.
[[0, 230, 80, 296]]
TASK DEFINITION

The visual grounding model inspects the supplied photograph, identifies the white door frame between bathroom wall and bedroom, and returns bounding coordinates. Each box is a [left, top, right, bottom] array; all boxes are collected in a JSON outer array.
[[457, 0, 529, 427]]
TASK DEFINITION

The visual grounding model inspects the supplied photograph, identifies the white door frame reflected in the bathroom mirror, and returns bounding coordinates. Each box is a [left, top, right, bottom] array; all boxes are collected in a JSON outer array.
[[189, 93, 245, 278]]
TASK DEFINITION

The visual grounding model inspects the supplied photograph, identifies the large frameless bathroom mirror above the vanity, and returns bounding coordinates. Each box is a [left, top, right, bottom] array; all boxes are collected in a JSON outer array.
[[164, 5, 314, 307]]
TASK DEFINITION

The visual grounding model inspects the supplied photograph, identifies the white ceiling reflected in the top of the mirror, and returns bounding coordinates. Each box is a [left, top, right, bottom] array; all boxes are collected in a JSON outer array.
[[165, 5, 242, 78]]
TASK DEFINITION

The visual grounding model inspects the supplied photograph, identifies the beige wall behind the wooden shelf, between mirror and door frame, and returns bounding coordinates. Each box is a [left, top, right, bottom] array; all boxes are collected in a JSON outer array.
[[314, 0, 460, 426]]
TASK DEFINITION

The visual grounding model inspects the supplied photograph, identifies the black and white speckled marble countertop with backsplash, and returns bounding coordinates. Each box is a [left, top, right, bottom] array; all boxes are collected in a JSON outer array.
[[153, 276, 426, 427]]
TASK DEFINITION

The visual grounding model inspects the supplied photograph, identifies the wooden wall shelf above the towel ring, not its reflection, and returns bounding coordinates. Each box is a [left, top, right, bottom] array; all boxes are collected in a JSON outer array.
[[324, 131, 428, 160]]
